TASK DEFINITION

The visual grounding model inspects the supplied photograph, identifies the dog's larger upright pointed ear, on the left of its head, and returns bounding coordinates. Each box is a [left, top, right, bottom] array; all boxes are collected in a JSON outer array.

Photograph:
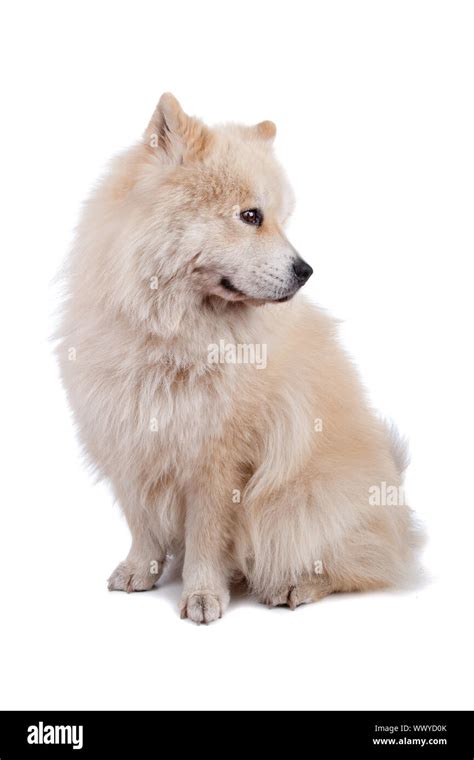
[[144, 92, 210, 164]]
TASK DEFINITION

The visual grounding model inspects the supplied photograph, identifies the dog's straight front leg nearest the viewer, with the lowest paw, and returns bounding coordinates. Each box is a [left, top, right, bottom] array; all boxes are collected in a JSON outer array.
[[181, 463, 231, 623]]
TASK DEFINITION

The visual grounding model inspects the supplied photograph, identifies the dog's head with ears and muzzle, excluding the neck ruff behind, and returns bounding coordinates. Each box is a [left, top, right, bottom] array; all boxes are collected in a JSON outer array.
[[136, 93, 312, 304]]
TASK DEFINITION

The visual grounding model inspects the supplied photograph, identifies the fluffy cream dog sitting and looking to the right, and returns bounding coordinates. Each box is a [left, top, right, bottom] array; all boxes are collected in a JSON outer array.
[[57, 93, 420, 623]]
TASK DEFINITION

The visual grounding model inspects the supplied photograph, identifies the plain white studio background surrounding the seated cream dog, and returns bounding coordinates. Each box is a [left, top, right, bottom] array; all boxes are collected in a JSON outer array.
[[0, 0, 474, 709]]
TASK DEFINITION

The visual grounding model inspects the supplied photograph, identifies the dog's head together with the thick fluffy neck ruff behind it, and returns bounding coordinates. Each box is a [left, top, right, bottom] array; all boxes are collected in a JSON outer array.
[[87, 94, 312, 335]]
